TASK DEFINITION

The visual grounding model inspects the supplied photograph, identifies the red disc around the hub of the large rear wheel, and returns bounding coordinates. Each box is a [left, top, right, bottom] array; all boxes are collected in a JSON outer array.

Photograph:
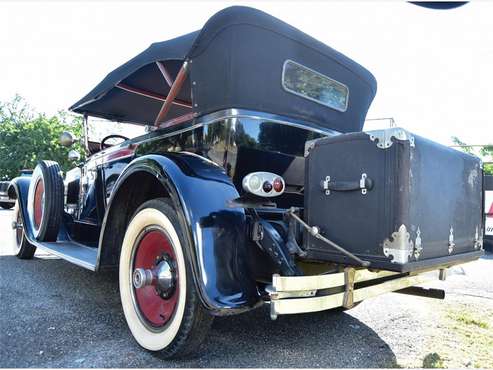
[[132, 229, 179, 328]]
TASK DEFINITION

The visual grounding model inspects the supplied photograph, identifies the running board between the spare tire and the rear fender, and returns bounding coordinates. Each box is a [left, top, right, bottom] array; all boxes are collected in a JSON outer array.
[[33, 241, 98, 271]]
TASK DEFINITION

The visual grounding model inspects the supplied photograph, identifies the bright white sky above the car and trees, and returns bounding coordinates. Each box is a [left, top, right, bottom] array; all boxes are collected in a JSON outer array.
[[0, 0, 493, 145]]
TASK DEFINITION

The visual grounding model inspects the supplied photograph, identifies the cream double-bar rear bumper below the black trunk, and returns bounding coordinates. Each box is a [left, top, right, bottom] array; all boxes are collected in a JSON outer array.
[[267, 267, 446, 320]]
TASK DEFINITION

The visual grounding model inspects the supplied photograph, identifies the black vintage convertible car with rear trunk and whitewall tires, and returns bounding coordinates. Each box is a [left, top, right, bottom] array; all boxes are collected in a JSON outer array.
[[9, 7, 484, 357]]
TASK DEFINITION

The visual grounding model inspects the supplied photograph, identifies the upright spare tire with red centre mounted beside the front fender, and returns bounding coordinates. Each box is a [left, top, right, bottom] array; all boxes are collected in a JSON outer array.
[[27, 161, 63, 242]]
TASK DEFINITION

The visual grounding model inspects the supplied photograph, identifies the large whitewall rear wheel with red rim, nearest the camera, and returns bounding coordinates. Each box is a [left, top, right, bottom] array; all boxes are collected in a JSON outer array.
[[119, 199, 212, 357]]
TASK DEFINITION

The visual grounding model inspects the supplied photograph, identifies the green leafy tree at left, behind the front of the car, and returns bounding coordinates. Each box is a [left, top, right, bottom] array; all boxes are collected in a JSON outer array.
[[0, 95, 84, 180]]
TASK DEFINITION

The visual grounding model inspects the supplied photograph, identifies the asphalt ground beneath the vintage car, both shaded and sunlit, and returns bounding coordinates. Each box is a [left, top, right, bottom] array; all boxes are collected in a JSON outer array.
[[0, 210, 493, 367]]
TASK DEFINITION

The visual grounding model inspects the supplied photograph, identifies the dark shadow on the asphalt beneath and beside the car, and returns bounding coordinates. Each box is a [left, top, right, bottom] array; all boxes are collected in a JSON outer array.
[[0, 256, 396, 367]]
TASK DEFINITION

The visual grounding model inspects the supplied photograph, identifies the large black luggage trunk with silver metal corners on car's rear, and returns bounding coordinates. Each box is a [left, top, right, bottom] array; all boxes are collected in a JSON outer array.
[[304, 128, 483, 272]]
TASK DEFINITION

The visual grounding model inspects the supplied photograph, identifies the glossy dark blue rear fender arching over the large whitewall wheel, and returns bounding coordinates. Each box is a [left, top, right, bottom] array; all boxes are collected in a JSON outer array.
[[100, 153, 261, 314]]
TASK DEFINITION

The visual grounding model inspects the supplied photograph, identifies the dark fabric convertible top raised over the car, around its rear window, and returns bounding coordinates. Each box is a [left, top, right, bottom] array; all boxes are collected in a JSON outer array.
[[70, 7, 376, 132]]
